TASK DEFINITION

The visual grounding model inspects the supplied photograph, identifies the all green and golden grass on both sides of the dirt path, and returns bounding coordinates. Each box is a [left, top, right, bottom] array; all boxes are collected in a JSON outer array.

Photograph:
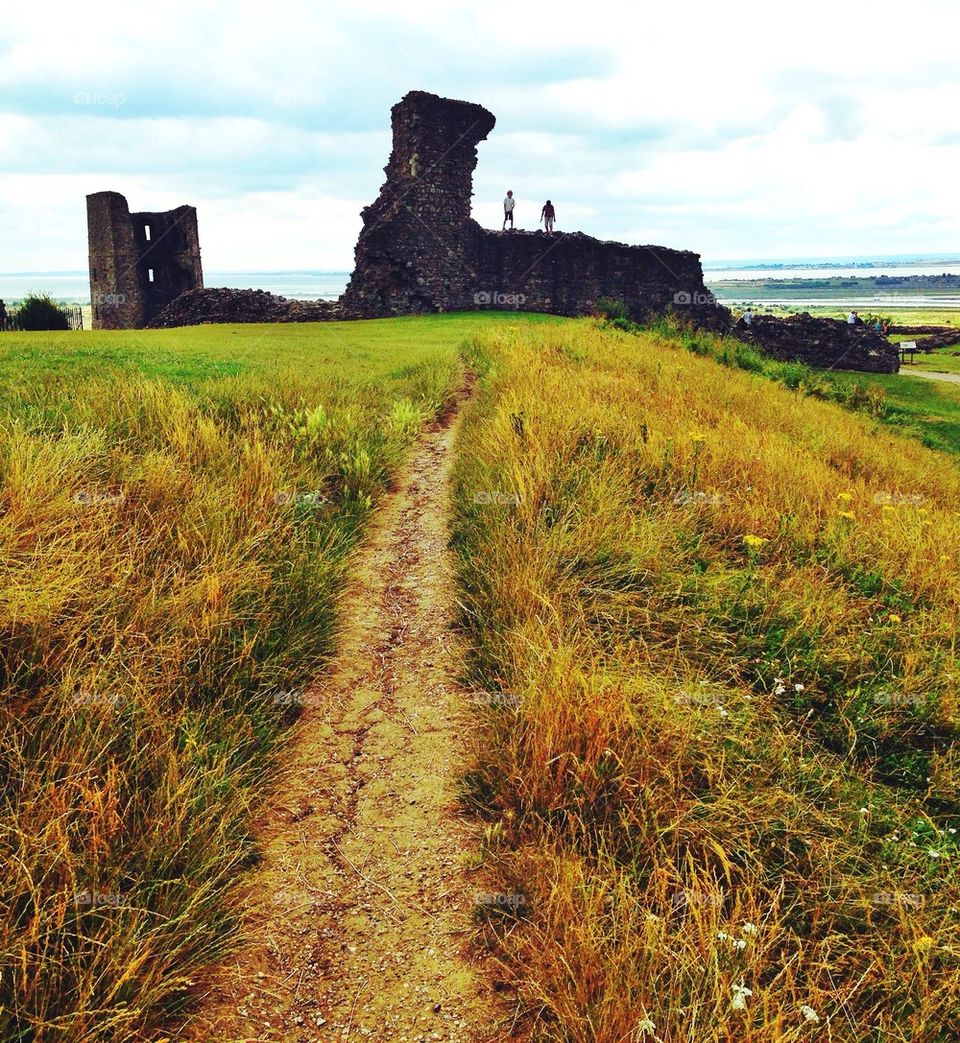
[[0, 313, 960, 1043]]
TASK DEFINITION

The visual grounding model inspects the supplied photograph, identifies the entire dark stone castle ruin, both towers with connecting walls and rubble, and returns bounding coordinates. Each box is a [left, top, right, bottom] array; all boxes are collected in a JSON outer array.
[[87, 91, 898, 372]]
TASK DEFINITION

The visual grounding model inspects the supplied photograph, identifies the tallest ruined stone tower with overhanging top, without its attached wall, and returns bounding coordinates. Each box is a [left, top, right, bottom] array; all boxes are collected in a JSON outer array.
[[342, 91, 497, 315]]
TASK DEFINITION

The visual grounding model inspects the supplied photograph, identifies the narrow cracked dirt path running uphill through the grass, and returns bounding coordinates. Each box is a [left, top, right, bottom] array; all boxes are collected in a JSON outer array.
[[184, 383, 506, 1043]]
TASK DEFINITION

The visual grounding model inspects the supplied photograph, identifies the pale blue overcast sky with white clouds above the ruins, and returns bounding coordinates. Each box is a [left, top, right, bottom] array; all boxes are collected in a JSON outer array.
[[0, 0, 960, 272]]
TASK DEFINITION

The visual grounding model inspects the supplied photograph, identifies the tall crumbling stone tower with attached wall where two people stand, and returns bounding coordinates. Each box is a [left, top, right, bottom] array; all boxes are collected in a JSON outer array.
[[341, 91, 728, 325]]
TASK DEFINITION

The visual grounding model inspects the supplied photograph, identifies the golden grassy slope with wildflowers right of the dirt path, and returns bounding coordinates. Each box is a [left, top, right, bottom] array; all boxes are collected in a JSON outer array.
[[455, 322, 960, 1043]]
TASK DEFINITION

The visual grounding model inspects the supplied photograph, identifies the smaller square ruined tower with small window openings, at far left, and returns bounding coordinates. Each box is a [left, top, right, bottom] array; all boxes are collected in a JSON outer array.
[[87, 192, 203, 330]]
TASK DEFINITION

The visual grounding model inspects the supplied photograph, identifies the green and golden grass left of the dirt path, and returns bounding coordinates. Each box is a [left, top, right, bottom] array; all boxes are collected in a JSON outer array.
[[0, 316, 550, 1043]]
